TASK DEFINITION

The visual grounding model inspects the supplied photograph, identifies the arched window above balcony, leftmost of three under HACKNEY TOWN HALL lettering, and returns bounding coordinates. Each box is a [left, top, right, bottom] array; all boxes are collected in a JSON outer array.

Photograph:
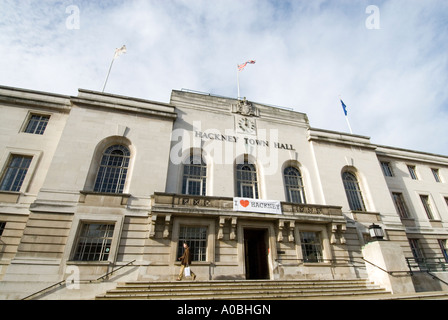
[[182, 156, 207, 196]]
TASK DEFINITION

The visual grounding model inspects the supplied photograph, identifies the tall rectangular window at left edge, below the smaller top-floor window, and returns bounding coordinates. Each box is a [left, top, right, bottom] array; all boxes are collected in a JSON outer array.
[[0, 155, 33, 192]]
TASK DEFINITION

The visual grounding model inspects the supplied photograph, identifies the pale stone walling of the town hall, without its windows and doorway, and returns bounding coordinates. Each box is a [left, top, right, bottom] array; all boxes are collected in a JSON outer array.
[[0, 87, 448, 298]]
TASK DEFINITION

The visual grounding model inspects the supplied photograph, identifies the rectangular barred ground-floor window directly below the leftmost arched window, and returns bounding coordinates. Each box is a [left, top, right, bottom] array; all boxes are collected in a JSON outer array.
[[73, 223, 114, 261]]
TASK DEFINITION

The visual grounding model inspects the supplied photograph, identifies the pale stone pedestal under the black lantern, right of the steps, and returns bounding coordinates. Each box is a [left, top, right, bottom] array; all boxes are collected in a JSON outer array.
[[362, 241, 415, 294]]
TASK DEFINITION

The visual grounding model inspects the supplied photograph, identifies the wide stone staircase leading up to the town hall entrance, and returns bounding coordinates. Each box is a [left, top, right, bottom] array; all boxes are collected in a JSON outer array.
[[96, 279, 391, 300]]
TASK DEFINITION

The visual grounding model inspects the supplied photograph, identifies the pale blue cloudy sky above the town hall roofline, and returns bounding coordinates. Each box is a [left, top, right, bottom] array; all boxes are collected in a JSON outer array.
[[0, 0, 448, 155]]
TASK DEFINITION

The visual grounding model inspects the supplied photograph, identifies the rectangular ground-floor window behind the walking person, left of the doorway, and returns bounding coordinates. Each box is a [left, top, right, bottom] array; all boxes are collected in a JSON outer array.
[[177, 226, 207, 261]]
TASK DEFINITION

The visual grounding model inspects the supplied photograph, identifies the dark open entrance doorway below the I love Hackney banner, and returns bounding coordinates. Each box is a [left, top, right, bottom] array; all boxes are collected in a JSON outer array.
[[244, 229, 269, 280]]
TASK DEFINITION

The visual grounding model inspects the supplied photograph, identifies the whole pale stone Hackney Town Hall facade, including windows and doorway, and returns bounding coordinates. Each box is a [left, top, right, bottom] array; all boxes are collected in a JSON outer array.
[[0, 87, 448, 299]]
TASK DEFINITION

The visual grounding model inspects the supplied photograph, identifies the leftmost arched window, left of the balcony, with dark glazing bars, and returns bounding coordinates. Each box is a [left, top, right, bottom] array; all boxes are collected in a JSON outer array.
[[93, 145, 131, 193]]
